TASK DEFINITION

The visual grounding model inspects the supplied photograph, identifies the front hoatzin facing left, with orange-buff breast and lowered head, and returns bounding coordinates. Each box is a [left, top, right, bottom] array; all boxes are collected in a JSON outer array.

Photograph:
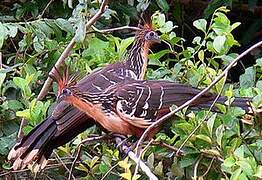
[[58, 80, 252, 137]]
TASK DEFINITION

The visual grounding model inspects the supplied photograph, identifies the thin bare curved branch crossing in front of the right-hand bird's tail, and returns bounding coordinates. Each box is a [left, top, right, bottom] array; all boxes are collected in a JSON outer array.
[[136, 41, 262, 165]]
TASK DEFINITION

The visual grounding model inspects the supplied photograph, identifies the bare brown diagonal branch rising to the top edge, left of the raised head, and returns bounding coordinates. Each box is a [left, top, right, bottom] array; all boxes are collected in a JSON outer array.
[[37, 0, 108, 100]]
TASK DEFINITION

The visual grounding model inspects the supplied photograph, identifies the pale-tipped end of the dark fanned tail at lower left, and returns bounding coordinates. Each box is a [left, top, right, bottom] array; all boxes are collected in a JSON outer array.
[[8, 118, 56, 170]]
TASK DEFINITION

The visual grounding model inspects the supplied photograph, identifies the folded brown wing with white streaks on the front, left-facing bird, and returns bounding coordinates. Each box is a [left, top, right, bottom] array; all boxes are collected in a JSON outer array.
[[115, 81, 213, 128]]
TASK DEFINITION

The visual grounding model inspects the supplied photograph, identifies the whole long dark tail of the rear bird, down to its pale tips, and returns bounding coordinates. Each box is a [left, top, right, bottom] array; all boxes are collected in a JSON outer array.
[[8, 106, 94, 172]]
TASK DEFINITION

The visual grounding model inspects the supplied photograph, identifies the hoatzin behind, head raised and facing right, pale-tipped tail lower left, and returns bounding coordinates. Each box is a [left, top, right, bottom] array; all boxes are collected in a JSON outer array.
[[8, 24, 160, 171]]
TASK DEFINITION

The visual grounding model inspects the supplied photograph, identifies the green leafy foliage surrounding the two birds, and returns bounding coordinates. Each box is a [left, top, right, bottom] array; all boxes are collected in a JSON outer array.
[[0, 0, 262, 179]]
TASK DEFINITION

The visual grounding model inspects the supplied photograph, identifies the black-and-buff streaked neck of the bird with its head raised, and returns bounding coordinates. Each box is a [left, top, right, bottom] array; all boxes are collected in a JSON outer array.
[[126, 38, 149, 79]]
